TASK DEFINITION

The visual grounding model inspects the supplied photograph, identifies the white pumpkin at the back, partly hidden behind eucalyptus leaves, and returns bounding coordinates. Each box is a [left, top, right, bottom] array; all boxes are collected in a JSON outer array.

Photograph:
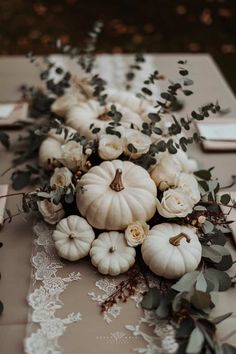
[[66, 99, 143, 139]]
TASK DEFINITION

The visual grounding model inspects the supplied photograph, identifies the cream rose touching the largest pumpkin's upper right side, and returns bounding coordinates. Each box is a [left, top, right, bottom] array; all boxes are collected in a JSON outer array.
[[150, 154, 182, 191]]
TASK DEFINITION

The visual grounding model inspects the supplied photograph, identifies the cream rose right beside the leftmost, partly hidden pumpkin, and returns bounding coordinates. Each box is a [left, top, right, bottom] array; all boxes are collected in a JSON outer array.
[[60, 140, 84, 171]]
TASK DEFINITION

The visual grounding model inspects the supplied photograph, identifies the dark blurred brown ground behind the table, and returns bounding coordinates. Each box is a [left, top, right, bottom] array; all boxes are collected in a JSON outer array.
[[0, 0, 236, 92]]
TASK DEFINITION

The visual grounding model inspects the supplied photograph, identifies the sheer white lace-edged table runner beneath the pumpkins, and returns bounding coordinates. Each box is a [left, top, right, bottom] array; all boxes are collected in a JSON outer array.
[[25, 56, 177, 354]]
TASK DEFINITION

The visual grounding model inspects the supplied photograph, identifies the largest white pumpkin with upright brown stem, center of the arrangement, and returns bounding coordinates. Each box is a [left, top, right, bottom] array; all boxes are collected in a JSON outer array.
[[76, 160, 157, 230]]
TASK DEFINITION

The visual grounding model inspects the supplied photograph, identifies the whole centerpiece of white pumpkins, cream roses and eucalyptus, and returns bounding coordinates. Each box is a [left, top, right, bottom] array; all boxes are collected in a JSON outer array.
[[1, 23, 235, 354]]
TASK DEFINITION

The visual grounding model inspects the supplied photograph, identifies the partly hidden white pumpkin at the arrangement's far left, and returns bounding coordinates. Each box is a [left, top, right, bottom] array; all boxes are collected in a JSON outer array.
[[39, 127, 76, 170]]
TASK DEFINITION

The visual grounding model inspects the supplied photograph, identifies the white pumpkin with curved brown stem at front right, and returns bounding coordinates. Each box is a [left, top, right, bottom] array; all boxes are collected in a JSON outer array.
[[141, 223, 202, 279]]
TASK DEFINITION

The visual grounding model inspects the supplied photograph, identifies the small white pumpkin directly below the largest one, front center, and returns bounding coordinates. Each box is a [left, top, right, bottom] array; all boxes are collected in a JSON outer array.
[[90, 231, 136, 276]]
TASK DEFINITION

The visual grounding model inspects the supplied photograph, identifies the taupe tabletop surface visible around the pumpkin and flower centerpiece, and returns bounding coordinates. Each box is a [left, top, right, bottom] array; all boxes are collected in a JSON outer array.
[[0, 54, 236, 354]]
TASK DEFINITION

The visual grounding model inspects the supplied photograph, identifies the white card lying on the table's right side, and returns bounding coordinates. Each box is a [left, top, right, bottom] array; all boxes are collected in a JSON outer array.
[[198, 122, 236, 141]]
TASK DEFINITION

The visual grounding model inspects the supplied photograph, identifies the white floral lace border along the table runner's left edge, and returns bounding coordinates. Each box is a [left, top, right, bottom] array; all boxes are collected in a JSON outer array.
[[25, 223, 81, 354]]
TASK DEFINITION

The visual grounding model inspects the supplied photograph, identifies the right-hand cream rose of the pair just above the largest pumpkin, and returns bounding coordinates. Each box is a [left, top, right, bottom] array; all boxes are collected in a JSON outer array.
[[125, 129, 152, 159]]
